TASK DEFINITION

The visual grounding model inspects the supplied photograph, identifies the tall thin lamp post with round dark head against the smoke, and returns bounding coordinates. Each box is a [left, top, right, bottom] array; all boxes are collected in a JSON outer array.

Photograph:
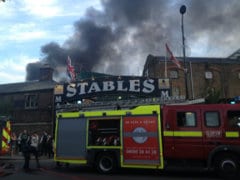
[[180, 5, 189, 100]]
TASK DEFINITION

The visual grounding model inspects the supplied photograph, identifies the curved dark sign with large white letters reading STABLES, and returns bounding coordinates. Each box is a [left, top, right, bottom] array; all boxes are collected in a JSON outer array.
[[54, 76, 170, 103]]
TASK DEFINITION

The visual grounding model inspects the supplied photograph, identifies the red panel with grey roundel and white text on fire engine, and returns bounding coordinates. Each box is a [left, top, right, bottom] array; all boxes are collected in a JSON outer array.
[[123, 116, 160, 165]]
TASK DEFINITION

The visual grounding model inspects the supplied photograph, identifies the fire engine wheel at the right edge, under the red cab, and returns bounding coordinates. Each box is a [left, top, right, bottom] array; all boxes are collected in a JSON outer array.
[[214, 153, 240, 179]]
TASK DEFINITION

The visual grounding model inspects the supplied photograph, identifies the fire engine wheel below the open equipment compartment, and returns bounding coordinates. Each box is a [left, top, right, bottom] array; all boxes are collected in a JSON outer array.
[[96, 153, 116, 174]]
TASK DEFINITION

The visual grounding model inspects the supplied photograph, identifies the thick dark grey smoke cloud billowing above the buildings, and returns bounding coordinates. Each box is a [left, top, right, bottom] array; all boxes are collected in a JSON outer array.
[[27, 0, 240, 80]]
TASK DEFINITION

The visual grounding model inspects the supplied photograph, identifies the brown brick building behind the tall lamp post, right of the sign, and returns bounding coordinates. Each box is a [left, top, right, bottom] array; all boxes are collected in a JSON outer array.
[[143, 50, 240, 99]]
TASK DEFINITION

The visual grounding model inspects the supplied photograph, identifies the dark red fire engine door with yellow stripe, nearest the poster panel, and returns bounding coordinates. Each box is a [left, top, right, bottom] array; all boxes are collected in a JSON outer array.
[[173, 109, 204, 159]]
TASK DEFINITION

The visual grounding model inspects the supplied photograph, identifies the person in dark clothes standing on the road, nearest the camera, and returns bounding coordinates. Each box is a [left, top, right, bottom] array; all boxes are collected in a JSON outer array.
[[21, 130, 30, 171]]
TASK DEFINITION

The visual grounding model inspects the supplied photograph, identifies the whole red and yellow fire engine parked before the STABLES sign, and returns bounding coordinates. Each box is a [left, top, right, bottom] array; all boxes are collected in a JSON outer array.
[[54, 104, 240, 177]]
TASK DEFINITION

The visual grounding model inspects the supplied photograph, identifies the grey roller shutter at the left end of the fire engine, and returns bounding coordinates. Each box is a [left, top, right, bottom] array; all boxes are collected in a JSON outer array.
[[56, 118, 87, 159]]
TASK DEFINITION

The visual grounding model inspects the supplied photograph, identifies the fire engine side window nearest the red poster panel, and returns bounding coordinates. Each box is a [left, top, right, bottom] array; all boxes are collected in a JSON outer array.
[[177, 112, 197, 127]]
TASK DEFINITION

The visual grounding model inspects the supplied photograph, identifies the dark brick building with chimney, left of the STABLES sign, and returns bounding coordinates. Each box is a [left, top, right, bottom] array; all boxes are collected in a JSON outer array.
[[0, 67, 56, 134]]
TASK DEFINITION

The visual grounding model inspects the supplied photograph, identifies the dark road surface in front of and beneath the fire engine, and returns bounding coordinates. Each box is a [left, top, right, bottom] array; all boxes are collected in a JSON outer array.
[[0, 157, 217, 180]]
